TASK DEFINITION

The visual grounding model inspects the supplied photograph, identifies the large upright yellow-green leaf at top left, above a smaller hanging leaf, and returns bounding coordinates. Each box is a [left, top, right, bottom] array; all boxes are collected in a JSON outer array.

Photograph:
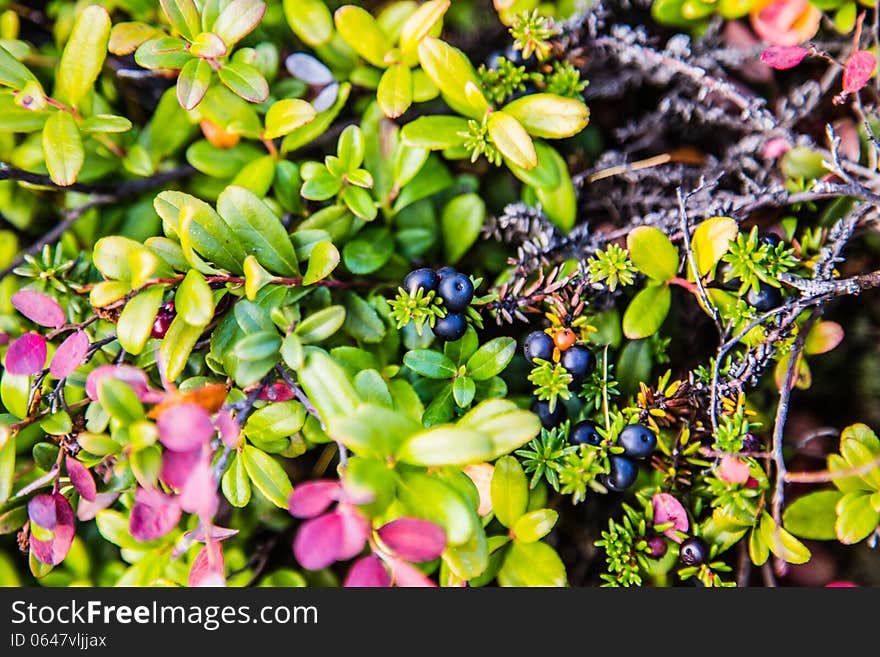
[[55, 5, 110, 107]]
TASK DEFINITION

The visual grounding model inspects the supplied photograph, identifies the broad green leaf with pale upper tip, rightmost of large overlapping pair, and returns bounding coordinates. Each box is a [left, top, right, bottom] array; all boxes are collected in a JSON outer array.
[[217, 185, 299, 276]]
